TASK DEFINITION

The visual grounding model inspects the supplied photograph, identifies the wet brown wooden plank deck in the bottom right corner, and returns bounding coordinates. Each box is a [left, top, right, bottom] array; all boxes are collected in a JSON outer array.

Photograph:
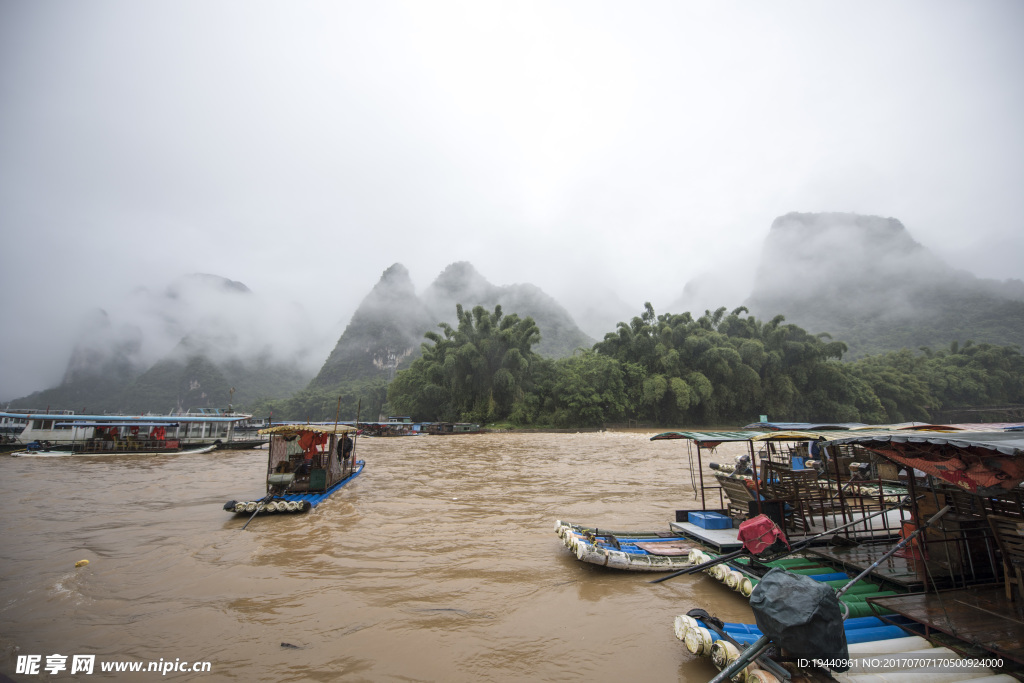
[[867, 585, 1024, 665]]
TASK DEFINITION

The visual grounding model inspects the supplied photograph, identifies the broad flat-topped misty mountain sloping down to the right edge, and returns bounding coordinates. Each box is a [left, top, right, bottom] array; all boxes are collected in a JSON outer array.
[[744, 213, 1024, 358]]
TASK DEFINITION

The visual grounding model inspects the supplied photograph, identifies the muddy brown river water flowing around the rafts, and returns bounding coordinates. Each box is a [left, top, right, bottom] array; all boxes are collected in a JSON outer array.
[[0, 431, 752, 683]]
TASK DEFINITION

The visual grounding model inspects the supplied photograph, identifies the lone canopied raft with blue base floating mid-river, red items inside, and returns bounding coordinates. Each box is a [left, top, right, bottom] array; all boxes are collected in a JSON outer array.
[[224, 424, 365, 515]]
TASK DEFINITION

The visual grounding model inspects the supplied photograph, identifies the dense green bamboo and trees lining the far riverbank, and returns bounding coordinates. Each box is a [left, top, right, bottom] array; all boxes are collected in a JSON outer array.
[[387, 304, 1024, 426]]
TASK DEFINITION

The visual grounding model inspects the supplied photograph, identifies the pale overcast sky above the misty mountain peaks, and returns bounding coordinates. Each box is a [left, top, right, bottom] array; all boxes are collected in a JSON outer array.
[[0, 0, 1024, 399]]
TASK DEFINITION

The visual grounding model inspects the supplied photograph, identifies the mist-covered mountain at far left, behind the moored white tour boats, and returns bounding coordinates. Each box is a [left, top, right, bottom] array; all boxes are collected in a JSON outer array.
[[12, 273, 313, 413]]
